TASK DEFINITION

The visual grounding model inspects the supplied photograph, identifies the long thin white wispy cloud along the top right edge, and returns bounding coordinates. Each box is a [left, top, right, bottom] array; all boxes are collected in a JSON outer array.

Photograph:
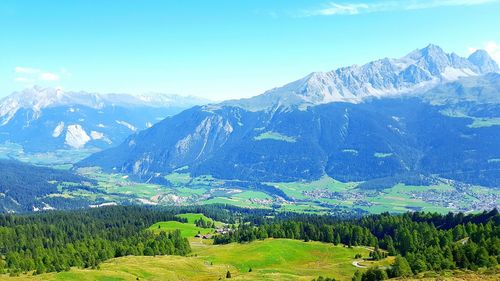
[[298, 0, 500, 17]]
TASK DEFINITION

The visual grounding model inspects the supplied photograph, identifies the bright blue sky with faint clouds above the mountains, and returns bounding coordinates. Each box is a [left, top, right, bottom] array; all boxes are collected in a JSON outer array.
[[0, 0, 500, 100]]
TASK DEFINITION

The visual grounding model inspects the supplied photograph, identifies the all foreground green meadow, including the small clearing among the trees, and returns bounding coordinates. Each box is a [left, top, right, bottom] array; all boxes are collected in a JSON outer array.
[[0, 213, 499, 281]]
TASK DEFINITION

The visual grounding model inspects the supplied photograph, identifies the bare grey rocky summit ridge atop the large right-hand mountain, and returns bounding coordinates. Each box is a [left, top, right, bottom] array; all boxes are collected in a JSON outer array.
[[228, 44, 498, 110]]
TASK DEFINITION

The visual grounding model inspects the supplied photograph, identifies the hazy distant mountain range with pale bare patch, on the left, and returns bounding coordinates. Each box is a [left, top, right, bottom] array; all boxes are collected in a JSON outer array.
[[0, 87, 207, 152]]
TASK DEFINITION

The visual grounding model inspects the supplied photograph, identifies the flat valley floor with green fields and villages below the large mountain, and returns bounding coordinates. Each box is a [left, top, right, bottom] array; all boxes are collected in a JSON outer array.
[[12, 162, 500, 214]]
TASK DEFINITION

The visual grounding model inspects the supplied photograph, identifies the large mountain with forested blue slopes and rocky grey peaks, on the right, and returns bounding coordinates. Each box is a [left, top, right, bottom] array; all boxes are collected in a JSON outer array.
[[79, 45, 500, 186]]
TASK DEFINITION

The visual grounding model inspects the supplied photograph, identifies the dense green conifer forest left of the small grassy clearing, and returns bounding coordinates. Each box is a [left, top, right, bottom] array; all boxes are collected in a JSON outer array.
[[0, 207, 191, 275]]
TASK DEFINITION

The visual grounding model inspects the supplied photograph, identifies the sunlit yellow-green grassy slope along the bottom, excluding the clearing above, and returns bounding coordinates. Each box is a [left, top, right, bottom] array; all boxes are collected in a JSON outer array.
[[2, 239, 384, 281]]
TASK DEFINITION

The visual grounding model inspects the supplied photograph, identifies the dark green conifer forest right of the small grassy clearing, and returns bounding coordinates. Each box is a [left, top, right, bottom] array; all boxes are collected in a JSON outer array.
[[214, 209, 500, 280]]
